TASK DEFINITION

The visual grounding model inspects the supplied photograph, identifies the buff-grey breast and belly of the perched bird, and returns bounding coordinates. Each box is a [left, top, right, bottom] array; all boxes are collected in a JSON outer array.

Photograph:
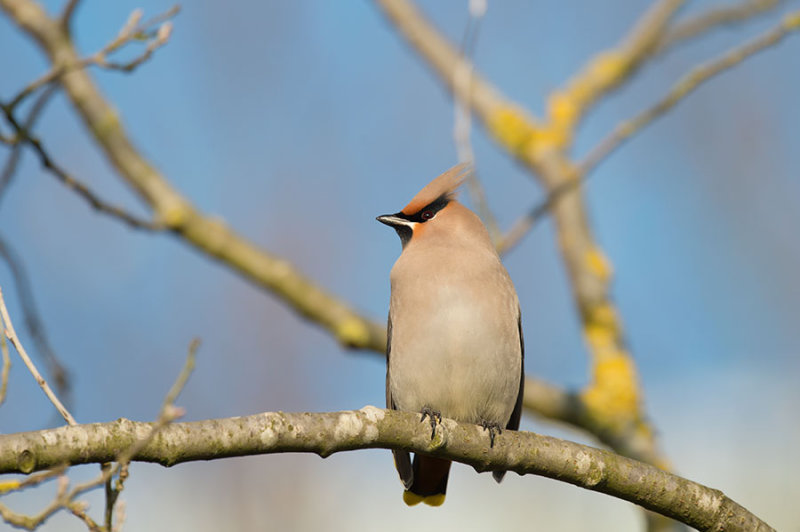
[[389, 261, 522, 425]]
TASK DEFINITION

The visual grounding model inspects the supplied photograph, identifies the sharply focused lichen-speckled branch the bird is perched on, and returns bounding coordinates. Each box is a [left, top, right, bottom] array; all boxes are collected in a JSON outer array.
[[0, 406, 772, 532]]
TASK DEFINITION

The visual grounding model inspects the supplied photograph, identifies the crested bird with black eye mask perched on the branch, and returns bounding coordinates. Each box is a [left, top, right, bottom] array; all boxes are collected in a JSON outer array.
[[377, 164, 525, 506]]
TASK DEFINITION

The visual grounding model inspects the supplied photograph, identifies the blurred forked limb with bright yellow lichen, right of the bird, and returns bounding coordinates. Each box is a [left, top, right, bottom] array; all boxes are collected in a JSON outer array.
[[376, 0, 668, 465]]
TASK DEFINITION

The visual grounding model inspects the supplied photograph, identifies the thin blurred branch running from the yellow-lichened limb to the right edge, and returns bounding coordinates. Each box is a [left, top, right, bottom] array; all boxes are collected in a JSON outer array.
[[572, 11, 800, 175]]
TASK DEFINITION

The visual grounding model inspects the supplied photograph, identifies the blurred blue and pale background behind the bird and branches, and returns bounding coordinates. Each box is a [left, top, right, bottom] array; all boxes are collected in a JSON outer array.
[[0, 0, 800, 531]]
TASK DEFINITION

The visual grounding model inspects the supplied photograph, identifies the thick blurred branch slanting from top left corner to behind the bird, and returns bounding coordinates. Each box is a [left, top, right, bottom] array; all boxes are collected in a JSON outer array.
[[0, 0, 386, 351]]
